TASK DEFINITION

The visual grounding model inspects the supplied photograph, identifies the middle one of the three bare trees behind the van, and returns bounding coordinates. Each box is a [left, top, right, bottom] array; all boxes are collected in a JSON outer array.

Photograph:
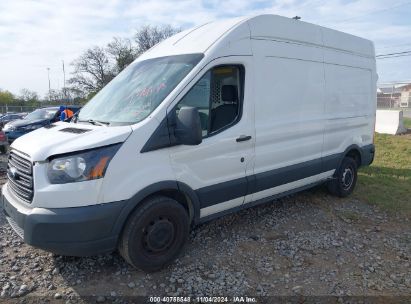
[[106, 37, 137, 73]]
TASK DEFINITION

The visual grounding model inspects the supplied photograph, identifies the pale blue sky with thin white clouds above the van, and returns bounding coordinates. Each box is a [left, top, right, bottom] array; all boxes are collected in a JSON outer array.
[[0, 0, 411, 96]]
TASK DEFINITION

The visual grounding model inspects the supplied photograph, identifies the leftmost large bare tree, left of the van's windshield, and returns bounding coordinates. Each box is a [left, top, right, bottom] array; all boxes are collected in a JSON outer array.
[[69, 46, 115, 92]]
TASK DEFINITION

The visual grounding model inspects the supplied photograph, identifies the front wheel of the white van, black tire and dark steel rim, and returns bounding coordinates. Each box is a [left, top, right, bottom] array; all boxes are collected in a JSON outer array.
[[118, 196, 190, 272]]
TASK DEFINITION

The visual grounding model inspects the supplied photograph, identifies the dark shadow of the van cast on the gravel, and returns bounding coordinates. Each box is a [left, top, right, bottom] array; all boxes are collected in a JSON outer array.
[[53, 187, 325, 300]]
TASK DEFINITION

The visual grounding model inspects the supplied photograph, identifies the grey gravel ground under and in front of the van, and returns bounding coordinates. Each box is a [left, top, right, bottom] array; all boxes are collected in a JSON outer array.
[[0, 152, 411, 303]]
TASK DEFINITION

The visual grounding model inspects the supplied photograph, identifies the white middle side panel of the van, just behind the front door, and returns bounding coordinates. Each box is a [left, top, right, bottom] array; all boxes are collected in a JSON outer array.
[[253, 41, 324, 174]]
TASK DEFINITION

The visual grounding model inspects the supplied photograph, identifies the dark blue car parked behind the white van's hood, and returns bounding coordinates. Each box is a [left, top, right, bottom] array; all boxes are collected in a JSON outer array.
[[3, 106, 81, 143]]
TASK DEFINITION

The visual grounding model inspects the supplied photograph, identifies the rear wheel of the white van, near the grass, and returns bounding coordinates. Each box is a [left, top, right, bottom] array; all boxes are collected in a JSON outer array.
[[327, 157, 358, 197]]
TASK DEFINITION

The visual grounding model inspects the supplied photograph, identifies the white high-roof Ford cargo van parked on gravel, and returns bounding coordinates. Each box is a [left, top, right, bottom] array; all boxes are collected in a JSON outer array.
[[2, 15, 377, 271]]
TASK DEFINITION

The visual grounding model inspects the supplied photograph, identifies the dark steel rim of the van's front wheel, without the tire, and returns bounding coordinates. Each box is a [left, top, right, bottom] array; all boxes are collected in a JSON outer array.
[[145, 219, 174, 252]]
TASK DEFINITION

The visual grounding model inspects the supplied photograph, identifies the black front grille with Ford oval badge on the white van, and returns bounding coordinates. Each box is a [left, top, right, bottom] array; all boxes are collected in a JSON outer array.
[[7, 151, 34, 204]]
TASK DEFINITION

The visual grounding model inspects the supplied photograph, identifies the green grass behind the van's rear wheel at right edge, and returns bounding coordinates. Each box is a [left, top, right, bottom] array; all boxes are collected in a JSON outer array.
[[354, 133, 411, 216]]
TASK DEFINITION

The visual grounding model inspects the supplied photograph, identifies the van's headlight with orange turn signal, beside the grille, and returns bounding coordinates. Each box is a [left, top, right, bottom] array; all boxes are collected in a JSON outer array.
[[47, 144, 121, 184]]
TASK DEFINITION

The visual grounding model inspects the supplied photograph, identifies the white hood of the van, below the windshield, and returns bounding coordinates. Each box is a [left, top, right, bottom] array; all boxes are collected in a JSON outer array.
[[11, 122, 132, 161]]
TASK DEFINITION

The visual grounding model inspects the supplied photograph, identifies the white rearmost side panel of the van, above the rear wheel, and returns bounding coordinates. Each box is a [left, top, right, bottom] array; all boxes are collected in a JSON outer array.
[[323, 63, 375, 156]]
